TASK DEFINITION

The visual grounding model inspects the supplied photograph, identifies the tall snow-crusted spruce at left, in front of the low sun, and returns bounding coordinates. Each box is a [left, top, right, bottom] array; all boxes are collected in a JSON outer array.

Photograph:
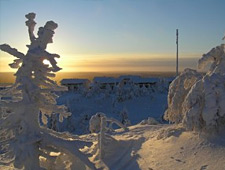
[[0, 13, 95, 170]]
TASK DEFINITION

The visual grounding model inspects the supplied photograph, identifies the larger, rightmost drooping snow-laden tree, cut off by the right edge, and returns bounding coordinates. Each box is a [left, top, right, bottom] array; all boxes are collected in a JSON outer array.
[[183, 44, 225, 131]]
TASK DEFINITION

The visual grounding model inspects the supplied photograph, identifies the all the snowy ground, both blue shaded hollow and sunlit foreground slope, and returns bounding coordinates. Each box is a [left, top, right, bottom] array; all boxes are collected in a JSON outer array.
[[0, 85, 225, 170]]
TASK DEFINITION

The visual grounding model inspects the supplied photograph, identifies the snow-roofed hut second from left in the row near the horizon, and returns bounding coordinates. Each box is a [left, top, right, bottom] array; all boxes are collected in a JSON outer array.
[[93, 77, 119, 90]]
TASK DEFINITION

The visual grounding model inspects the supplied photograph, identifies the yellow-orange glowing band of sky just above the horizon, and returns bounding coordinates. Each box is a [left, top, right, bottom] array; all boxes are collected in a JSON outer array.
[[0, 52, 200, 72]]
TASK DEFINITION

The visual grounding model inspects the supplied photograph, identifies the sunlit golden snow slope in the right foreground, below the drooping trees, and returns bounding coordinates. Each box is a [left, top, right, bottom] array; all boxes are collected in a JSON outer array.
[[78, 124, 225, 170]]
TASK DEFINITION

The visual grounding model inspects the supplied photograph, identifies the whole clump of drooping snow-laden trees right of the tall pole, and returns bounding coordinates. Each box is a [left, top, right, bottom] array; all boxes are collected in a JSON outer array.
[[165, 41, 225, 132]]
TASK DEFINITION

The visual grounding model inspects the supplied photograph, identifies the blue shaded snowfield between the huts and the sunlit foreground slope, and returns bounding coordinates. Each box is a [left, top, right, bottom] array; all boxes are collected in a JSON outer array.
[[55, 92, 167, 134]]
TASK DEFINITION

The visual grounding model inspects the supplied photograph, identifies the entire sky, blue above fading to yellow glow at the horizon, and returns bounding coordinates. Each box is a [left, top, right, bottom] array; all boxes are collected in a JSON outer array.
[[0, 0, 225, 72]]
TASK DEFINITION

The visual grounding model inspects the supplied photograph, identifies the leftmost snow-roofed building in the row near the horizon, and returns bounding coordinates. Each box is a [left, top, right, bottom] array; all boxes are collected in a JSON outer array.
[[60, 79, 91, 91]]
